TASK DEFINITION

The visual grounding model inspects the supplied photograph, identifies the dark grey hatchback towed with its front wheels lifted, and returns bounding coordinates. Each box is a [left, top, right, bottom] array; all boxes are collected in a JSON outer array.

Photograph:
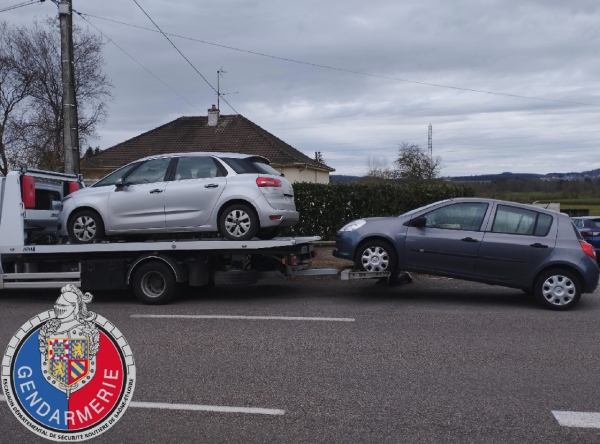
[[333, 198, 600, 310]]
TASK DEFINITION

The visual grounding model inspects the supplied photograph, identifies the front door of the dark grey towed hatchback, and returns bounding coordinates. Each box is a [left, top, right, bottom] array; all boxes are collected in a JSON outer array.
[[404, 201, 489, 275]]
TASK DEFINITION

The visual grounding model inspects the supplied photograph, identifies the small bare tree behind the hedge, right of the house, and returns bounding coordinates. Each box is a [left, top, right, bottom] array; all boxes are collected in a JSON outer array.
[[395, 142, 442, 182]]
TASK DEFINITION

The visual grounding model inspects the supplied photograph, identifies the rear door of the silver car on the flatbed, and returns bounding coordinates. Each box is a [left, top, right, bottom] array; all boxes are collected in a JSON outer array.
[[165, 156, 227, 228]]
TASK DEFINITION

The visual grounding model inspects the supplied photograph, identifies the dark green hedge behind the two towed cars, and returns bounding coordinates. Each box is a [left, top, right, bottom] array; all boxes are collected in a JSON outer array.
[[282, 182, 475, 240]]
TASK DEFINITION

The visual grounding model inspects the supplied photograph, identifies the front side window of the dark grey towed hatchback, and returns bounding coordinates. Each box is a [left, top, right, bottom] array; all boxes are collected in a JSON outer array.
[[424, 202, 488, 231]]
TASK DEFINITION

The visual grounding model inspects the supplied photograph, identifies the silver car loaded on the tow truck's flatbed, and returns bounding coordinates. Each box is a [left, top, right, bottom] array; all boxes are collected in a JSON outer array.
[[59, 153, 298, 243]]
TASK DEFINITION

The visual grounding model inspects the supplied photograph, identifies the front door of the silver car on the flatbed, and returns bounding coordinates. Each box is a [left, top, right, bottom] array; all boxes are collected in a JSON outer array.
[[108, 157, 171, 231]]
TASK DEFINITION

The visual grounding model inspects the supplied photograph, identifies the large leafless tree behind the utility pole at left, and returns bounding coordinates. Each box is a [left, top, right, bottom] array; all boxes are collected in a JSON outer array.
[[7, 18, 112, 171]]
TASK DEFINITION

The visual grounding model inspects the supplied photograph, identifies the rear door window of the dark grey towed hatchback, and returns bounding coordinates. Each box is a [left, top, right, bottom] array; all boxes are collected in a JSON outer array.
[[492, 205, 553, 236]]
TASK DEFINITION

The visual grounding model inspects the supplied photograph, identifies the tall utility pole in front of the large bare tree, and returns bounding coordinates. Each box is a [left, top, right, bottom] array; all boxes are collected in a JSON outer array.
[[58, 0, 79, 174]]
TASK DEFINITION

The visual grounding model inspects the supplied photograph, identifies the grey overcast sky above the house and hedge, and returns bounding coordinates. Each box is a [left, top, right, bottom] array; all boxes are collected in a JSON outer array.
[[0, 0, 600, 176]]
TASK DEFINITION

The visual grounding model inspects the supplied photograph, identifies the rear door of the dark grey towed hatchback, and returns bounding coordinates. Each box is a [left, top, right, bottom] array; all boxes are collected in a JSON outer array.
[[475, 204, 558, 280]]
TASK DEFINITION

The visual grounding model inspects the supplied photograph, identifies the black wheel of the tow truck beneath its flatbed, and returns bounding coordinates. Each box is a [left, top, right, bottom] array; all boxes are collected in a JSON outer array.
[[133, 261, 181, 305]]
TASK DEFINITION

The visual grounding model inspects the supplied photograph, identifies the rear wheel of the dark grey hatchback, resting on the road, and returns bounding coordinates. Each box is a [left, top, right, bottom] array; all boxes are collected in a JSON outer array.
[[533, 268, 581, 310]]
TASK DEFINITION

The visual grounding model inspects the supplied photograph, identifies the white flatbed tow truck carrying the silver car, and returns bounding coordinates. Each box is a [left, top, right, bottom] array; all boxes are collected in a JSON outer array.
[[0, 168, 389, 305]]
